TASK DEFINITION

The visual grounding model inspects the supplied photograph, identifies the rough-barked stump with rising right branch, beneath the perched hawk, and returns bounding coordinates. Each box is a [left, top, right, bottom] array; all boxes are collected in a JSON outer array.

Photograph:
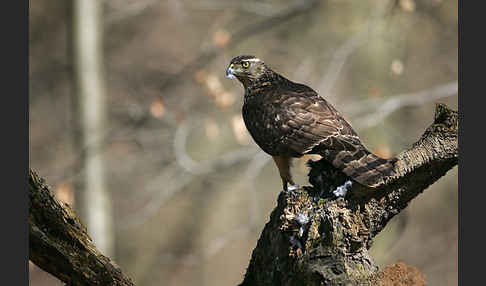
[[240, 104, 458, 285]]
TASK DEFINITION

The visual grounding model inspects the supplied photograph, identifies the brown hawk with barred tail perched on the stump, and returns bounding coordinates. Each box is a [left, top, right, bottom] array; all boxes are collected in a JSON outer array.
[[226, 55, 396, 191]]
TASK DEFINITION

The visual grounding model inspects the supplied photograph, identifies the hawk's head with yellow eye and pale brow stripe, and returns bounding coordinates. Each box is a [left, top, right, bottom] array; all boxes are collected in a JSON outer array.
[[226, 56, 268, 88]]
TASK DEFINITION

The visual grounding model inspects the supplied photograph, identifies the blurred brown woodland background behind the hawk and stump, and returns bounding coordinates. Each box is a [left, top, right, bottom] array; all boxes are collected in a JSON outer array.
[[29, 0, 458, 286]]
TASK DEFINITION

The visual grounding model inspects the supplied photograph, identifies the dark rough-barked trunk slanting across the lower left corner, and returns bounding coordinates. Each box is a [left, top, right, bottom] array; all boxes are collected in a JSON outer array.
[[29, 170, 133, 286]]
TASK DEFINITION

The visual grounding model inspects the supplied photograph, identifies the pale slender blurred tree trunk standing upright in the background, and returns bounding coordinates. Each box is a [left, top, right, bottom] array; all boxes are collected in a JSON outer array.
[[73, 0, 114, 257]]
